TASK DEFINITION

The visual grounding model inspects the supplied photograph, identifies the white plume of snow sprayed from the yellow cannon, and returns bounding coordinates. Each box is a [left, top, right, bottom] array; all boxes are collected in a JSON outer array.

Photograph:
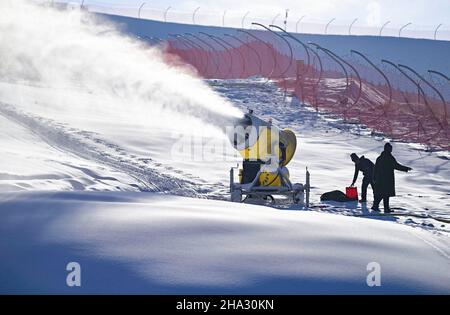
[[0, 0, 241, 132]]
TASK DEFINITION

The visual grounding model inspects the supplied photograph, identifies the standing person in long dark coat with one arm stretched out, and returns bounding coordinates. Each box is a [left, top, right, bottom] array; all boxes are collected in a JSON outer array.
[[372, 143, 412, 213]]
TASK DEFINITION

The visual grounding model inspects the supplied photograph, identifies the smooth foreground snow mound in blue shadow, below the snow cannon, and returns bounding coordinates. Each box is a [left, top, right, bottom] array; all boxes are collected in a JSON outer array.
[[0, 192, 450, 294]]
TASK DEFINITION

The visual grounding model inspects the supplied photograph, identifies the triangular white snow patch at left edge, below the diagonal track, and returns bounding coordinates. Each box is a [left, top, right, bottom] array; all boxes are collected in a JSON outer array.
[[0, 112, 136, 191]]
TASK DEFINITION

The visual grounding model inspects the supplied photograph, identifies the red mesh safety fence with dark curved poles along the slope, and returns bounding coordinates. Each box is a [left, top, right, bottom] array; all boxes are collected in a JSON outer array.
[[167, 30, 450, 150]]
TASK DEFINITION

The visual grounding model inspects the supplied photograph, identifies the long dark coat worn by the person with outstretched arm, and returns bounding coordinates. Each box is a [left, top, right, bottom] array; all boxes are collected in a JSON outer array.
[[373, 151, 409, 197]]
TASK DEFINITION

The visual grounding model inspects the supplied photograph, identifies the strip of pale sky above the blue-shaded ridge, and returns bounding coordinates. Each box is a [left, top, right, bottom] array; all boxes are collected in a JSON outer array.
[[79, 0, 450, 29]]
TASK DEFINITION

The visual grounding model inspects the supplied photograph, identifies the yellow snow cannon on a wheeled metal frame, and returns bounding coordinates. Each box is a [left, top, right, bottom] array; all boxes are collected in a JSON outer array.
[[227, 110, 309, 204]]
